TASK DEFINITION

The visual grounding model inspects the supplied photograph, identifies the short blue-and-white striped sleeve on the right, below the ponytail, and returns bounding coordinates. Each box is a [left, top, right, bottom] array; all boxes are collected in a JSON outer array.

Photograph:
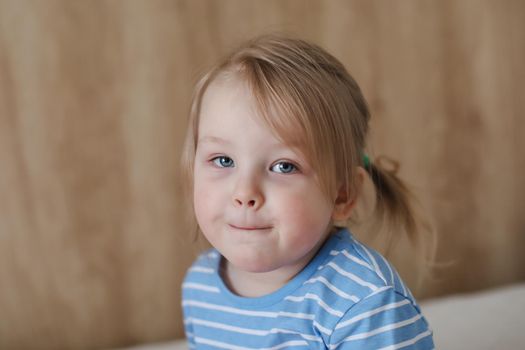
[[329, 288, 434, 350]]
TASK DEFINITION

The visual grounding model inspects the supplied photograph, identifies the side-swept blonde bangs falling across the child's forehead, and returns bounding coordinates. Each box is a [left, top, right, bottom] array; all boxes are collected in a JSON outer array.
[[234, 58, 336, 196]]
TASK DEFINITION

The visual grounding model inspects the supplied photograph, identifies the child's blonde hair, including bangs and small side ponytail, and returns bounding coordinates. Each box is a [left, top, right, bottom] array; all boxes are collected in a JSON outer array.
[[182, 34, 432, 266]]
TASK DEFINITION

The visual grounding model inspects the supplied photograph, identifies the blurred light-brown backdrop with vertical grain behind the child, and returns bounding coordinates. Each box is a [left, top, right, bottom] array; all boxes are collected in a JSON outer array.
[[0, 0, 525, 349]]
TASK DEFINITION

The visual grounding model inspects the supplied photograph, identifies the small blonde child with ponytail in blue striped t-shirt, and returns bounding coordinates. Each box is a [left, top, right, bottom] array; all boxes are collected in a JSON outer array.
[[182, 35, 434, 349]]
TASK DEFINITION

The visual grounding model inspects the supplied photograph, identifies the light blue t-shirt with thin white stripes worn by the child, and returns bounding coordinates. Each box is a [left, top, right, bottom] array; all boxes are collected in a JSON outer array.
[[182, 230, 434, 349]]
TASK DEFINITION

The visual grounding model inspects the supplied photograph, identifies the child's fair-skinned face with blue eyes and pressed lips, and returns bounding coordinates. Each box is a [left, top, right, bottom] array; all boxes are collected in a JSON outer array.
[[194, 78, 334, 273]]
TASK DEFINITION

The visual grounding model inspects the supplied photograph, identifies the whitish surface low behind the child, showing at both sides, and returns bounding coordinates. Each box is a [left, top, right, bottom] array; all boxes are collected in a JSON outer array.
[[115, 283, 525, 350]]
